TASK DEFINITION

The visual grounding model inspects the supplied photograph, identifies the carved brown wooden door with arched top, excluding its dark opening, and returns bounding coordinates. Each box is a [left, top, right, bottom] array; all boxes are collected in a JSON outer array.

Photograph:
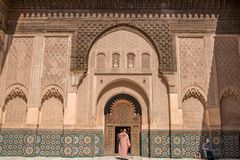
[[104, 99, 141, 155]]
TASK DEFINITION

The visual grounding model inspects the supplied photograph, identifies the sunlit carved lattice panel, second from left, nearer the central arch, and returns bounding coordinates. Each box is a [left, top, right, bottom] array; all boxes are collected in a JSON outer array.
[[41, 37, 69, 88]]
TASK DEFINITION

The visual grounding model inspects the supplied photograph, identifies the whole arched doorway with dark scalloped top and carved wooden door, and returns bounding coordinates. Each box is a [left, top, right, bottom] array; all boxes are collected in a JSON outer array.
[[104, 94, 142, 155]]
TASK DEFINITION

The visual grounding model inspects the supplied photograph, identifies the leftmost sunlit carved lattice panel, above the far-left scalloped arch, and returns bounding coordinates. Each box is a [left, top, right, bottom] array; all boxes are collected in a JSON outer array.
[[6, 37, 34, 88]]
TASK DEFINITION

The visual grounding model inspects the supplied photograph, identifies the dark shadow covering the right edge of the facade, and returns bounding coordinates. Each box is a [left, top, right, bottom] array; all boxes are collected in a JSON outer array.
[[206, 1, 240, 158]]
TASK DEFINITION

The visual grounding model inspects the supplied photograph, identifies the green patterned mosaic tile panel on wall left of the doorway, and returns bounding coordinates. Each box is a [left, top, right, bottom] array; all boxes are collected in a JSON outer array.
[[0, 129, 103, 157]]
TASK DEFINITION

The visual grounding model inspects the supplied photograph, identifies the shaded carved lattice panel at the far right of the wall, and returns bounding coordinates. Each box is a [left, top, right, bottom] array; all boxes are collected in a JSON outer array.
[[214, 37, 240, 96]]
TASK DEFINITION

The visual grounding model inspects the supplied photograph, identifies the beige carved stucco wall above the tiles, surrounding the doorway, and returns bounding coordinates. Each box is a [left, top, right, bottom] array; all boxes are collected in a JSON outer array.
[[0, 7, 240, 135]]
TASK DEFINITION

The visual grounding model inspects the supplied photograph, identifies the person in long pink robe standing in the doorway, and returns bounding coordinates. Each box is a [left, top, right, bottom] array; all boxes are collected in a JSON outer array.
[[118, 129, 131, 159]]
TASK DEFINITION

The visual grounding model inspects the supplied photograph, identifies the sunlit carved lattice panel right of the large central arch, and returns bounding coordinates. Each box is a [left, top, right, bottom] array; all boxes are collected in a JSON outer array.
[[179, 38, 206, 90]]
